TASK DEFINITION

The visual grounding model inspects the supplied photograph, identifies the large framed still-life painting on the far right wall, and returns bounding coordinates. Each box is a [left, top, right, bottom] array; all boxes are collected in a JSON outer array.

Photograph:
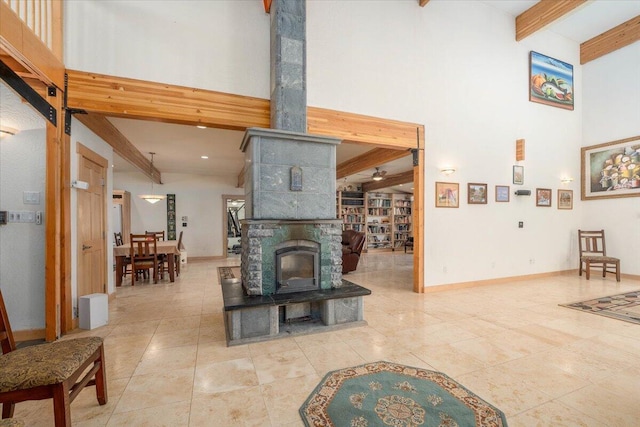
[[580, 135, 640, 200]]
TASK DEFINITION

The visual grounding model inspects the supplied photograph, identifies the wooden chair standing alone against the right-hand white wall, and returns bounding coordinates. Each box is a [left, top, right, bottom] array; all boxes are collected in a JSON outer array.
[[578, 230, 620, 282]]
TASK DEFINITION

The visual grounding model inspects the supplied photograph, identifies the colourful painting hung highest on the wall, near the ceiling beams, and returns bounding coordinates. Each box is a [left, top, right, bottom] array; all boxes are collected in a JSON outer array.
[[529, 51, 573, 110]]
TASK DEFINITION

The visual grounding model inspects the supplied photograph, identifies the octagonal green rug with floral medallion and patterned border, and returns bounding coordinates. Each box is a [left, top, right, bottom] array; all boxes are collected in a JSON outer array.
[[300, 362, 507, 427]]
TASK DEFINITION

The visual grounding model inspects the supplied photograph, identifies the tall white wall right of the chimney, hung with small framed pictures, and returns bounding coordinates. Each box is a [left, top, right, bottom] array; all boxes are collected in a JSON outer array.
[[307, 1, 582, 286]]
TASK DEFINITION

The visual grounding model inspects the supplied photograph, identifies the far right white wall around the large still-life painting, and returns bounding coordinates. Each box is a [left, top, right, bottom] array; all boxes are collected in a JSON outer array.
[[580, 42, 640, 275]]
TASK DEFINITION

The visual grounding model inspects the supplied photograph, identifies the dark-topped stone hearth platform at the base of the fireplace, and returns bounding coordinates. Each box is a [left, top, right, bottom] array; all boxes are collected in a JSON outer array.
[[221, 279, 371, 346]]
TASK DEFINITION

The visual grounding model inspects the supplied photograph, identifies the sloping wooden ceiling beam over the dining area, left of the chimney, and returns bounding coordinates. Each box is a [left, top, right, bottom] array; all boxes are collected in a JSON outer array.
[[73, 113, 162, 184]]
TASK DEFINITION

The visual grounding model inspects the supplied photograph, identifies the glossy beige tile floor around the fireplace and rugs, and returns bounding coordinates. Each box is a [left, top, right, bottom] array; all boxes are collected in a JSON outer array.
[[11, 253, 640, 427]]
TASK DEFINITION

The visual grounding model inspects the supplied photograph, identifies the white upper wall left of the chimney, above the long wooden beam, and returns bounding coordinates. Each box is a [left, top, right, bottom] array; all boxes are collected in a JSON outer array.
[[64, 0, 269, 98]]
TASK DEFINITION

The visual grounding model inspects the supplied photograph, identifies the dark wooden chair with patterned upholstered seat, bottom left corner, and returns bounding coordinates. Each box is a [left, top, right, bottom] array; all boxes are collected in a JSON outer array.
[[0, 292, 107, 427]]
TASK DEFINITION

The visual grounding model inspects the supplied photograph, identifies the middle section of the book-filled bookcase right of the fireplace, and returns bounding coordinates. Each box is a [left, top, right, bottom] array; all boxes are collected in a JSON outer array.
[[366, 193, 393, 250]]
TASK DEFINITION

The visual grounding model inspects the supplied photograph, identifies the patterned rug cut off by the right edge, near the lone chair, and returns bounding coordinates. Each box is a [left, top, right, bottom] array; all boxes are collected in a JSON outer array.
[[560, 291, 640, 324]]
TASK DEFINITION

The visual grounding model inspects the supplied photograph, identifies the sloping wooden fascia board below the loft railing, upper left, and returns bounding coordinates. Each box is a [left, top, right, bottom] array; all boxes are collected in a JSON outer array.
[[0, 1, 64, 88]]
